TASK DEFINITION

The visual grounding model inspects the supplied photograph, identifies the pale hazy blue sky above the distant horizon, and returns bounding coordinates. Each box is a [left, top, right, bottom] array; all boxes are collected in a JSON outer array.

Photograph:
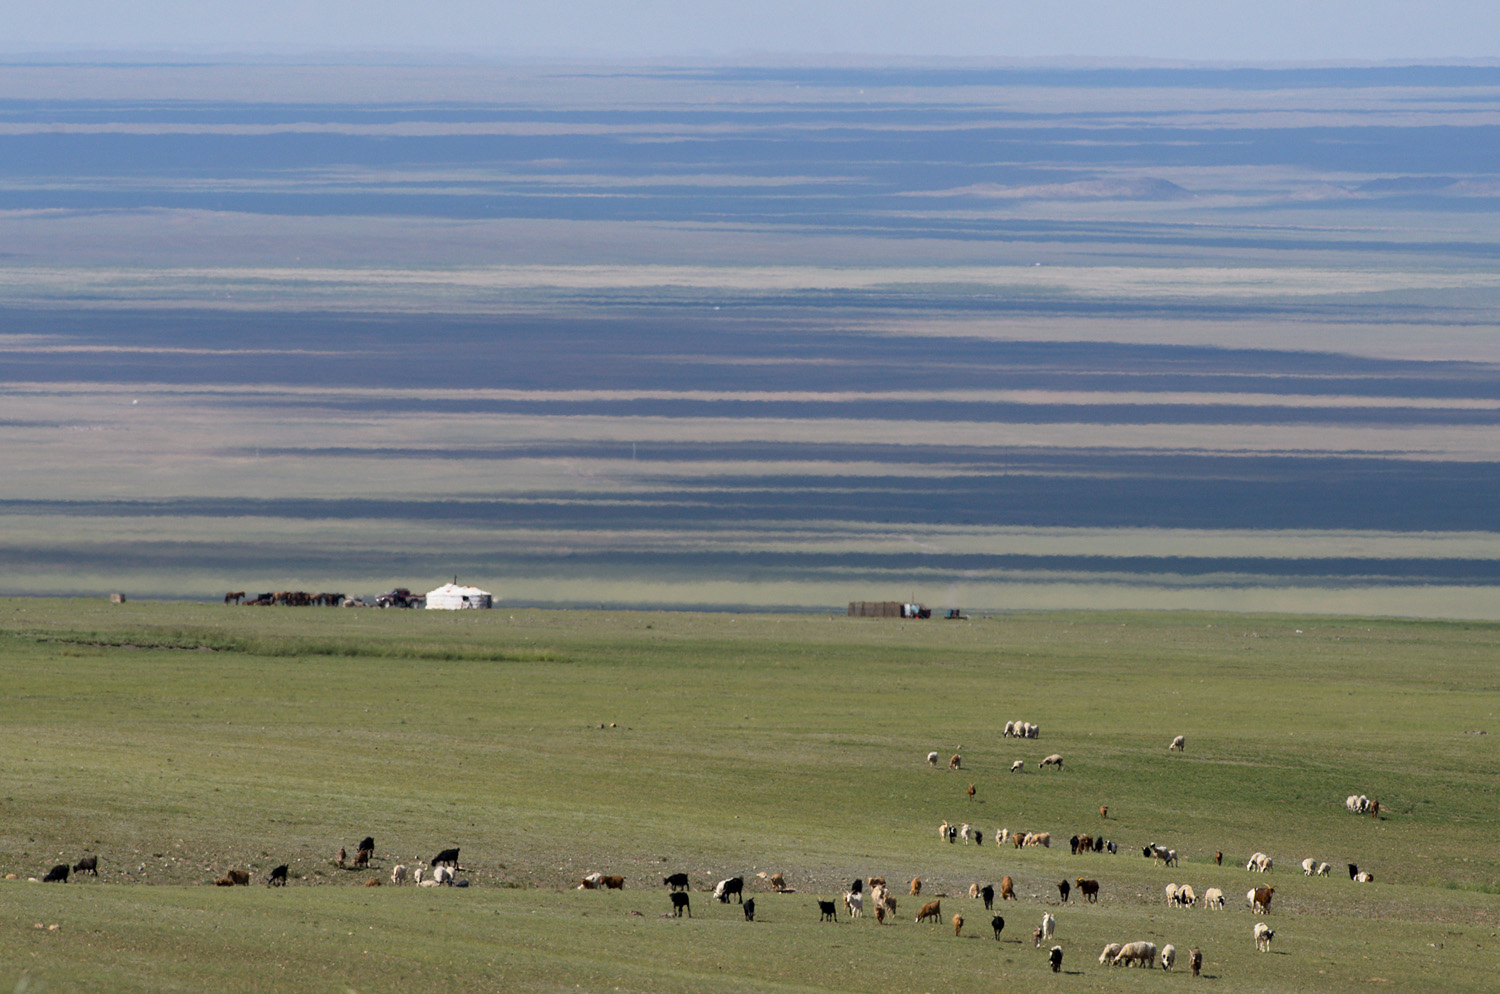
[[0, 0, 1500, 63]]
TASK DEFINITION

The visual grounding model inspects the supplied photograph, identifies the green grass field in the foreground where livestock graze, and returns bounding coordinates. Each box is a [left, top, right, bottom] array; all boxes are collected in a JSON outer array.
[[0, 600, 1500, 993]]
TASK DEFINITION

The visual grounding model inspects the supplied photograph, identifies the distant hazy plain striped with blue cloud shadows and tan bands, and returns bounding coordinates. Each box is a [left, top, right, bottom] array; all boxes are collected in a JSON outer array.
[[0, 64, 1500, 618]]
